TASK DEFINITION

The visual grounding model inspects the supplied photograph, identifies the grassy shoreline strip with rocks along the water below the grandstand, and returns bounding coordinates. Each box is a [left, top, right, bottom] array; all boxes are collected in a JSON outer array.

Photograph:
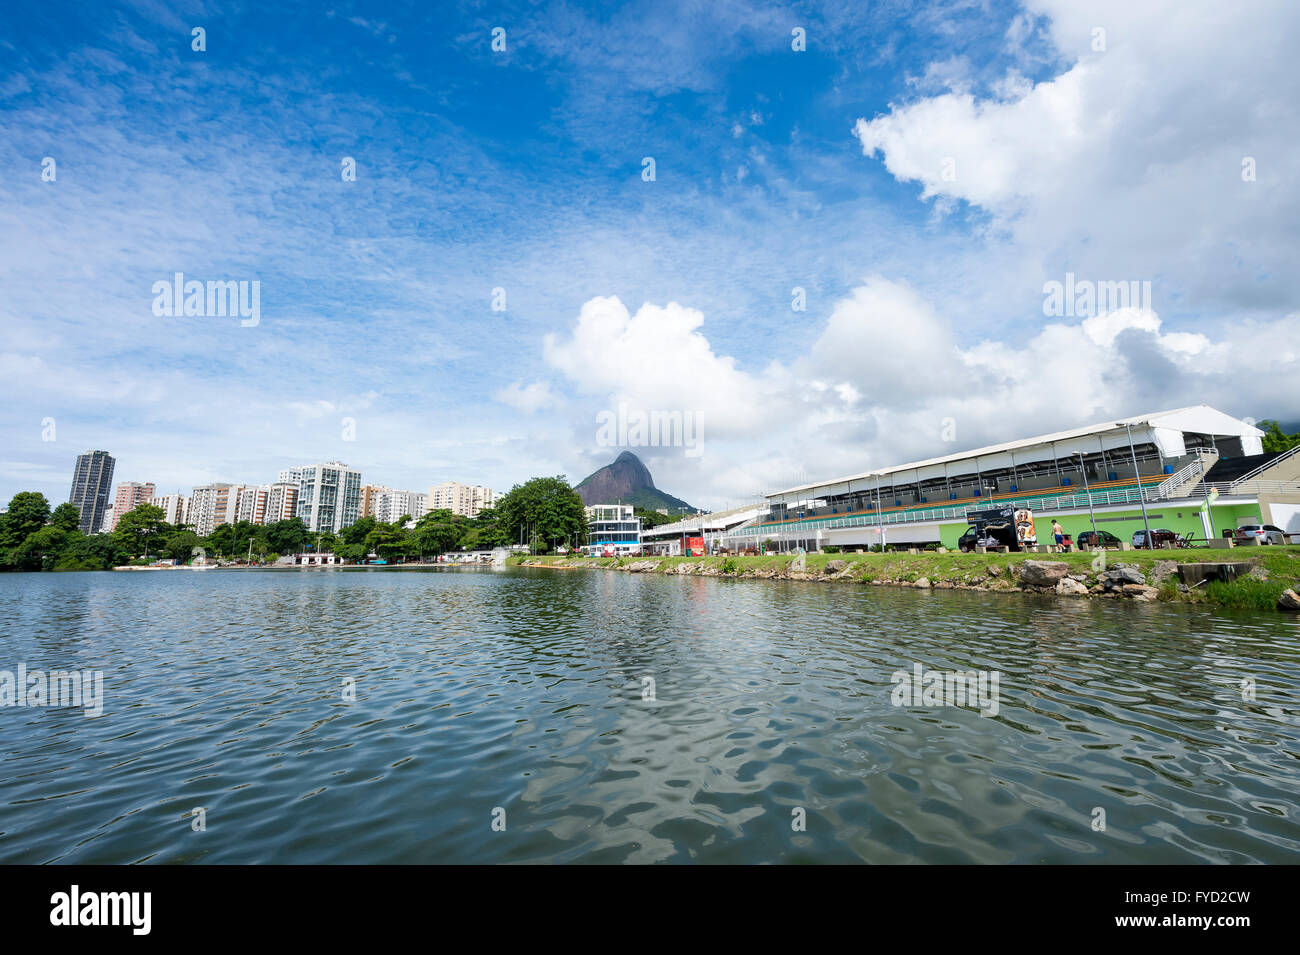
[[507, 546, 1300, 612]]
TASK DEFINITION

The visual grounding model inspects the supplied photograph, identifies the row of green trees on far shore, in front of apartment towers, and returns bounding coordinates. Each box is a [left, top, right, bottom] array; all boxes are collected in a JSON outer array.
[[0, 476, 586, 570]]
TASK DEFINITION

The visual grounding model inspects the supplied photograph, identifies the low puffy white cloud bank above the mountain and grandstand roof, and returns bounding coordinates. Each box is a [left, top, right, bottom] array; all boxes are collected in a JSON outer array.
[[525, 283, 1300, 502]]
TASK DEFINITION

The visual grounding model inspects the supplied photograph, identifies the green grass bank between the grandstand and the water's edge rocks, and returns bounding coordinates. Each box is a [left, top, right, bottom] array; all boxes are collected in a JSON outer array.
[[510, 546, 1300, 609]]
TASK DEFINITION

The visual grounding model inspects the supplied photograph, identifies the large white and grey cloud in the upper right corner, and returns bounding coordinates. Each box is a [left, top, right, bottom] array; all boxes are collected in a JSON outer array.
[[854, 0, 1300, 311]]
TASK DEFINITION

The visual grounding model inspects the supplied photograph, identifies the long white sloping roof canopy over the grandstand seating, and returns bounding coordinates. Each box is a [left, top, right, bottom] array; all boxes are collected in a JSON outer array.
[[766, 404, 1264, 503]]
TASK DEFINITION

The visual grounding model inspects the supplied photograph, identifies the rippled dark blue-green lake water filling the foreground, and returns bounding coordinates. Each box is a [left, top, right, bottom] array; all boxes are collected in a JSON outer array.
[[0, 568, 1300, 863]]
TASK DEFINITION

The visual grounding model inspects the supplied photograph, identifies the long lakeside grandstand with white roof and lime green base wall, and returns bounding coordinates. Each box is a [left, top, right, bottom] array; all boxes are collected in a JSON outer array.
[[706, 404, 1300, 551]]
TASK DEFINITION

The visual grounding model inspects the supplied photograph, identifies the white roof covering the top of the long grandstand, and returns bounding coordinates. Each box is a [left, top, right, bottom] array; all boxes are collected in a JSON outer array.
[[767, 404, 1264, 499]]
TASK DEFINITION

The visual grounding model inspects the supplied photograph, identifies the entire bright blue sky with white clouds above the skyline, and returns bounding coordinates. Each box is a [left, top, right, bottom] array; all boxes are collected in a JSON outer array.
[[0, 0, 1300, 505]]
